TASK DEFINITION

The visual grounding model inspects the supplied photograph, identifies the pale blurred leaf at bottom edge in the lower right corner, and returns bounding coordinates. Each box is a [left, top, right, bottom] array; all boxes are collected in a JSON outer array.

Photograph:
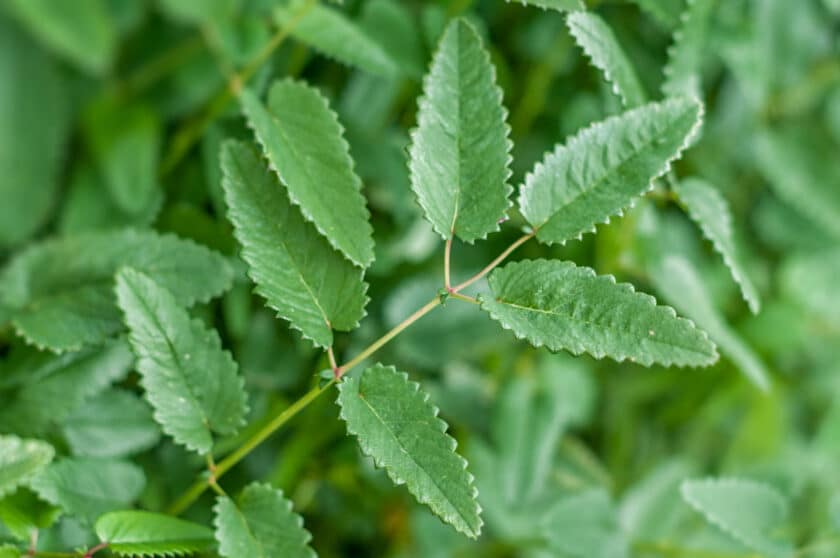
[[680, 478, 791, 556]]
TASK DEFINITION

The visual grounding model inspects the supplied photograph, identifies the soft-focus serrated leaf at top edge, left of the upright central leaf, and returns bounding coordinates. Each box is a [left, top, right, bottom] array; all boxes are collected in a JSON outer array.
[[274, 0, 399, 76]]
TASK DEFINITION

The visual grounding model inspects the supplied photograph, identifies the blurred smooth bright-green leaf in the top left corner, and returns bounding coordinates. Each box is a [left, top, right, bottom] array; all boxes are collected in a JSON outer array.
[[7, 0, 117, 74]]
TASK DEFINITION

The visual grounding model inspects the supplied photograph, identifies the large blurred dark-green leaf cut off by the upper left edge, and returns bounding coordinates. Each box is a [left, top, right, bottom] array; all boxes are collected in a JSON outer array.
[[0, 16, 71, 247]]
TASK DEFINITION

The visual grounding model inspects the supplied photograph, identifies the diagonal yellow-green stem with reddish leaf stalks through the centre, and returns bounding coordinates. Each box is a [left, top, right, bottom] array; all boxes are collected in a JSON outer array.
[[167, 232, 535, 515]]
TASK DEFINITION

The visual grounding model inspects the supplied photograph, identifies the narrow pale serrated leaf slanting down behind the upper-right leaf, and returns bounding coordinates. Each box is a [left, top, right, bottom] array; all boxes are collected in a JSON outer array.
[[566, 11, 647, 108]]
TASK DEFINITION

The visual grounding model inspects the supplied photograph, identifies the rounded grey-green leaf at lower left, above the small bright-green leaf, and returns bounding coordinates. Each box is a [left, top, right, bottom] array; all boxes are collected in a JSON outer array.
[[29, 458, 146, 523]]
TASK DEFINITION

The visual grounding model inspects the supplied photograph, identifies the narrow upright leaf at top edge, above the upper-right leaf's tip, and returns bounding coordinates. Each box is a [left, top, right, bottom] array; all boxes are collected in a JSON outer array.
[[662, 0, 717, 98]]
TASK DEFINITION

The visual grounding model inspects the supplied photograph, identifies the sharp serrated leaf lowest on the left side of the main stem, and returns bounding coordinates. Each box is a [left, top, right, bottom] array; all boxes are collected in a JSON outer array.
[[116, 268, 247, 454]]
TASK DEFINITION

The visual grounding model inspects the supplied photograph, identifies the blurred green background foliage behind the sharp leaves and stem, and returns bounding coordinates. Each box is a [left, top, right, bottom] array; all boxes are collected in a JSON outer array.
[[0, 0, 840, 558]]
